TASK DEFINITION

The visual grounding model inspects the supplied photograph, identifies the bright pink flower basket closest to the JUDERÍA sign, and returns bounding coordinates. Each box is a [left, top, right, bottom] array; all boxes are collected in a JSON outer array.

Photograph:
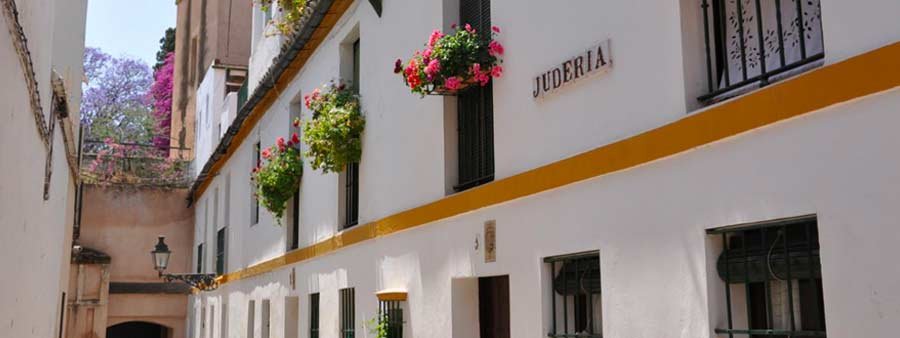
[[394, 24, 503, 97]]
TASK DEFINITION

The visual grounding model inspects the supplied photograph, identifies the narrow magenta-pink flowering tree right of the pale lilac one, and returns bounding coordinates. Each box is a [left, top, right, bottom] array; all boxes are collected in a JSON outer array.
[[150, 53, 175, 150]]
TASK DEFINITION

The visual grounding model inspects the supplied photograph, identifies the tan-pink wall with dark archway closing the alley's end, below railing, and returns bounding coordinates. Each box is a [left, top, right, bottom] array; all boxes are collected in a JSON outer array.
[[66, 184, 193, 338]]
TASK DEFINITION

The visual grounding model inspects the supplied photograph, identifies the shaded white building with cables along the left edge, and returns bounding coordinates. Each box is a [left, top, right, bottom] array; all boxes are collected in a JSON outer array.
[[0, 0, 87, 338]]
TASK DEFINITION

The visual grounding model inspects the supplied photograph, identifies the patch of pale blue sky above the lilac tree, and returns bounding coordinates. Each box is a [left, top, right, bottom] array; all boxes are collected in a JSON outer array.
[[85, 0, 176, 65]]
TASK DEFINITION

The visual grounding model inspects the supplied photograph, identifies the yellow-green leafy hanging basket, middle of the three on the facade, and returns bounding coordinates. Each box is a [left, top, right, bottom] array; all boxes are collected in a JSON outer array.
[[303, 83, 366, 173]]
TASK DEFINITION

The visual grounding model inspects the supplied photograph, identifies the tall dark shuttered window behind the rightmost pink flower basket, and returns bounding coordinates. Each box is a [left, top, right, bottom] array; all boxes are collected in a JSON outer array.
[[454, 0, 494, 191]]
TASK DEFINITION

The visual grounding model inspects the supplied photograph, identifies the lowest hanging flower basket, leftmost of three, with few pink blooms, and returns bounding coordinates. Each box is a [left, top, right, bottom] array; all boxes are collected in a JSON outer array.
[[250, 133, 303, 225]]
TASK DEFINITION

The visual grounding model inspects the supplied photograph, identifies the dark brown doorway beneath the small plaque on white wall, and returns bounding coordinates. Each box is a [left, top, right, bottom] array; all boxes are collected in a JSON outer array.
[[474, 276, 509, 338]]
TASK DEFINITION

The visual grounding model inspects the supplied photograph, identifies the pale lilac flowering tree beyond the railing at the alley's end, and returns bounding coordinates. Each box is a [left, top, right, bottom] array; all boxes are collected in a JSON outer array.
[[81, 48, 154, 143]]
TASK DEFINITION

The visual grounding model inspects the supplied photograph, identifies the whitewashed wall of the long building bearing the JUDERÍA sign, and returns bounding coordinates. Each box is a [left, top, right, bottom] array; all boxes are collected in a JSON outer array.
[[190, 0, 900, 338]]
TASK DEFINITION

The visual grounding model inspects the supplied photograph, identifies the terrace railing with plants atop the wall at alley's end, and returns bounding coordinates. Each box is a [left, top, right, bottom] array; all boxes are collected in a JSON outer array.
[[81, 140, 191, 188]]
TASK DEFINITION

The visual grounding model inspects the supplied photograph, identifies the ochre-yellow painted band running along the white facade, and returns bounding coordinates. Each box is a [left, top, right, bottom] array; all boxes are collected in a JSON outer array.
[[213, 43, 900, 283]]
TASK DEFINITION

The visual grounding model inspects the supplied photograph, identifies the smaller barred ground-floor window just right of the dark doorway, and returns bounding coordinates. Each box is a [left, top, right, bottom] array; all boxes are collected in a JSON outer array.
[[544, 251, 602, 338]]
